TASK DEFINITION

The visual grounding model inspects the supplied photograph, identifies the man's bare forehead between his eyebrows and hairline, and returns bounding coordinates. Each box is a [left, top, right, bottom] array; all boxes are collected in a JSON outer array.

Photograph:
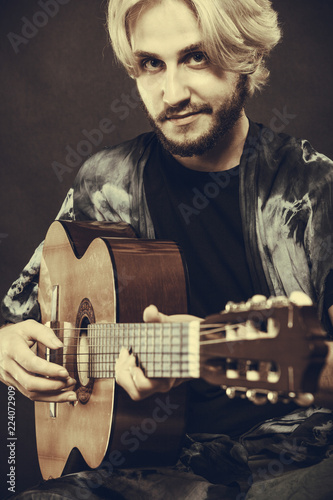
[[130, 0, 202, 57]]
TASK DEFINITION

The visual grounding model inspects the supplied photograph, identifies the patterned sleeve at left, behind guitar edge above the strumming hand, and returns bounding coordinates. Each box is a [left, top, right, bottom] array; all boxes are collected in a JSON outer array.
[[1, 189, 74, 323]]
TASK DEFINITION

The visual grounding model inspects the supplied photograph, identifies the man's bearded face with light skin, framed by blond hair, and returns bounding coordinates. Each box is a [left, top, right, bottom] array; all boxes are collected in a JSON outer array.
[[130, 0, 247, 157]]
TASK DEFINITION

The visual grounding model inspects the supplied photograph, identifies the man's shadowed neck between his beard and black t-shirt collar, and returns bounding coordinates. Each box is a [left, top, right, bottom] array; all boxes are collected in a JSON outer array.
[[175, 110, 249, 172]]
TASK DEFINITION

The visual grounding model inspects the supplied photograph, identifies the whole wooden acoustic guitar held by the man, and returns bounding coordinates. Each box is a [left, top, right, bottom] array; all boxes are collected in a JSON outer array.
[[35, 221, 327, 479]]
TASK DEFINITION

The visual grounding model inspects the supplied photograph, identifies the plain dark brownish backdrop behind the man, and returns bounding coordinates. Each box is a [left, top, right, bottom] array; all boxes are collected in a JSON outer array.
[[0, 0, 333, 498]]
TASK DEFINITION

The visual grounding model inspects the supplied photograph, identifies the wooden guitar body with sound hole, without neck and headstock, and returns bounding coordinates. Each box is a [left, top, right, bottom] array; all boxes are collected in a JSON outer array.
[[35, 221, 187, 479]]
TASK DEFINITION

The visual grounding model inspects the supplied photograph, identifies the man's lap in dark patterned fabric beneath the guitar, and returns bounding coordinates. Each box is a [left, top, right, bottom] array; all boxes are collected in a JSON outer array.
[[13, 410, 333, 500]]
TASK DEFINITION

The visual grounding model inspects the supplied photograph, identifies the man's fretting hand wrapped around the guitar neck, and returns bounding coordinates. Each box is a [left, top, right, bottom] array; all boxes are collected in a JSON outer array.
[[116, 305, 202, 401]]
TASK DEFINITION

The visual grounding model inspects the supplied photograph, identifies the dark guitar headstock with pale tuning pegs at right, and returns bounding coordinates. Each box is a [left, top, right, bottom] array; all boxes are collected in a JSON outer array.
[[200, 296, 327, 403]]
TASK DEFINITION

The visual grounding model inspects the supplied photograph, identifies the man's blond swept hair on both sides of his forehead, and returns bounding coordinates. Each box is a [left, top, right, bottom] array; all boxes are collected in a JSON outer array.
[[108, 0, 281, 95]]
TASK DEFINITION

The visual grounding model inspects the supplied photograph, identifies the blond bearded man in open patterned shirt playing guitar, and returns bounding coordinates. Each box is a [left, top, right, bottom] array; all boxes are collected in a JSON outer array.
[[0, 0, 333, 498]]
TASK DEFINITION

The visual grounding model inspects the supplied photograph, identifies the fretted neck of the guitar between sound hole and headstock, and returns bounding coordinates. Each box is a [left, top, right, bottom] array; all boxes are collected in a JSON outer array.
[[88, 321, 200, 378]]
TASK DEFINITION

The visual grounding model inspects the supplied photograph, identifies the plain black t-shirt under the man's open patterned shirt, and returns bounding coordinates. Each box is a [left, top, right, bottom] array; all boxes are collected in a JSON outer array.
[[144, 143, 295, 435]]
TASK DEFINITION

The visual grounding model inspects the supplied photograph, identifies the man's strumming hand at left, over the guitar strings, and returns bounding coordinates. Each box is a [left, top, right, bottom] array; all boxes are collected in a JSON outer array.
[[0, 320, 76, 403]]
